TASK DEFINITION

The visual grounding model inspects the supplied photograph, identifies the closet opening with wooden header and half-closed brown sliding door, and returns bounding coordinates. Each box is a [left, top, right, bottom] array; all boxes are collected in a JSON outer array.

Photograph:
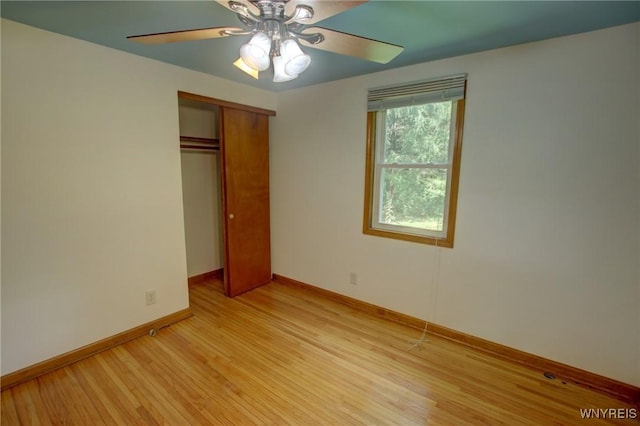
[[178, 92, 275, 297]]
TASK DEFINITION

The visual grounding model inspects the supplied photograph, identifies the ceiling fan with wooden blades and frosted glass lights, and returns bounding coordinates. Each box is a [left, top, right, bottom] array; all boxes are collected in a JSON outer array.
[[127, 0, 404, 83]]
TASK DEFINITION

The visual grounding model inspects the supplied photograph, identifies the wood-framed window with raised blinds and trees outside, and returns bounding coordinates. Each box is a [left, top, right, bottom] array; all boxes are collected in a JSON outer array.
[[363, 75, 466, 247]]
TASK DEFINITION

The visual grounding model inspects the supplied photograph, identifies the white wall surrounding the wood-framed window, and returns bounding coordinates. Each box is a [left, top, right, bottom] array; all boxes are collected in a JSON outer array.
[[271, 24, 640, 385]]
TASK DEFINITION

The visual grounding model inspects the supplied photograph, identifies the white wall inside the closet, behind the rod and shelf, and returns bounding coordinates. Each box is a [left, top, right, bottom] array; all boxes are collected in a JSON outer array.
[[179, 102, 223, 277]]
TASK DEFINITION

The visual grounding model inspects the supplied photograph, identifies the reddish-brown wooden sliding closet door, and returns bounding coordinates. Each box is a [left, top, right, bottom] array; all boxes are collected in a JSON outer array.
[[220, 107, 271, 297]]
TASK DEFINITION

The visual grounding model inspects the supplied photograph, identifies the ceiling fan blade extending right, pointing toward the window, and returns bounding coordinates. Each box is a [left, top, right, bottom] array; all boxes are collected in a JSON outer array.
[[299, 27, 404, 64]]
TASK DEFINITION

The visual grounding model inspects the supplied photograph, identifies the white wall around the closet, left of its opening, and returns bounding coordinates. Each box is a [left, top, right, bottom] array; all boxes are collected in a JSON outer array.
[[2, 20, 276, 374]]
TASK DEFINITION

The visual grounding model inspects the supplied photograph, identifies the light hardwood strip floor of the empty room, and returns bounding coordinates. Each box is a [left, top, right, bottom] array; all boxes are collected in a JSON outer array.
[[1, 281, 631, 425]]
